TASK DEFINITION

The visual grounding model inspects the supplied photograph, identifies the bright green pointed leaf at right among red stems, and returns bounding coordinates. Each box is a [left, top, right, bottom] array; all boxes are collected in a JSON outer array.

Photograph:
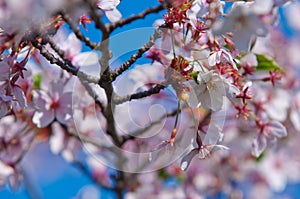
[[255, 54, 284, 71]]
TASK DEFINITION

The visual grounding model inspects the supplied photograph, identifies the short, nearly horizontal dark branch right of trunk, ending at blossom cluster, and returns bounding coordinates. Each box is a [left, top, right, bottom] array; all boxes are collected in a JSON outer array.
[[114, 82, 167, 105]]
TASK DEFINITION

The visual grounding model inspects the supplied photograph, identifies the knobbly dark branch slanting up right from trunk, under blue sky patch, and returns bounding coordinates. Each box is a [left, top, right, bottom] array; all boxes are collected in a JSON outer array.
[[112, 28, 161, 80]]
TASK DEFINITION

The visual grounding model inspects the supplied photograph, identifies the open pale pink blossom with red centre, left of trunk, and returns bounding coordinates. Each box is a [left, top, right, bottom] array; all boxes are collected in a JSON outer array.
[[32, 81, 72, 128]]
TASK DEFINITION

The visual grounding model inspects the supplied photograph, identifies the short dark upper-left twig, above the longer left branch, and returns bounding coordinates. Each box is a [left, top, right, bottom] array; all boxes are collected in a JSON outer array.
[[61, 12, 99, 49]]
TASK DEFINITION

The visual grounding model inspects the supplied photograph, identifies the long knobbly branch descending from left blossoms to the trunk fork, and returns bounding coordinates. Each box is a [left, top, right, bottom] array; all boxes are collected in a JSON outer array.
[[31, 40, 99, 84]]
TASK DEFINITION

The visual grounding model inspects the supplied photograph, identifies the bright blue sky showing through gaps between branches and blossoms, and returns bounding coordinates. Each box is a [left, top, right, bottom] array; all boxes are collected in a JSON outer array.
[[0, 0, 300, 199]]
